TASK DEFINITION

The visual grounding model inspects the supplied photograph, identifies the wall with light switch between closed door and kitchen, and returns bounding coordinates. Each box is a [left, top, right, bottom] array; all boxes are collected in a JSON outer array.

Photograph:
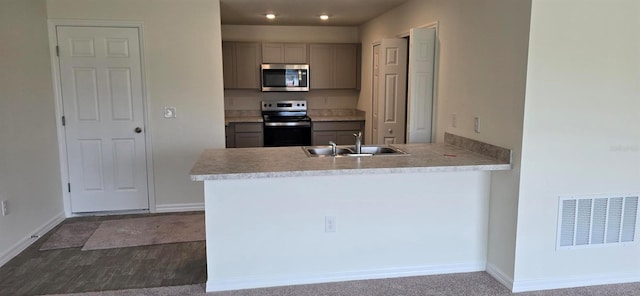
[[47, 0, 224, 210]]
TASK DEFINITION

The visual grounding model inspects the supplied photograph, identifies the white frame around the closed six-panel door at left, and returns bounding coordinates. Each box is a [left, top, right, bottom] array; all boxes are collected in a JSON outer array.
[[48, 19, 156, 217]]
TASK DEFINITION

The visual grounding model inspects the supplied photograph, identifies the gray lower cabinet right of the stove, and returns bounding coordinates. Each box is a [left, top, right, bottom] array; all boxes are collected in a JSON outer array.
[[313, 121, 364, 145]]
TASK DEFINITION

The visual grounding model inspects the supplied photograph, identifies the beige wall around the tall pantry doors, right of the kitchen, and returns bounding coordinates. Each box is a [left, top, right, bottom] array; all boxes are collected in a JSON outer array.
[[358, 0, 531, 279]]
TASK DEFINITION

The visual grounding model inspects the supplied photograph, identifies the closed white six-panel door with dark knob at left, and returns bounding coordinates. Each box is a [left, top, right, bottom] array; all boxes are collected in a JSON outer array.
[[56, 26, 149, 213]]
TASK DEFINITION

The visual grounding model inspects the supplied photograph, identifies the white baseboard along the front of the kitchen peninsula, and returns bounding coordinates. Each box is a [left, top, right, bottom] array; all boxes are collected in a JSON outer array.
[[206, 262, 485, 292]]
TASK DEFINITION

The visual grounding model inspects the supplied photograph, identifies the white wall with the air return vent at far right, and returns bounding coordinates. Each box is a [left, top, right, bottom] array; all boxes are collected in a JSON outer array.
[[514, 0, 640, 290]]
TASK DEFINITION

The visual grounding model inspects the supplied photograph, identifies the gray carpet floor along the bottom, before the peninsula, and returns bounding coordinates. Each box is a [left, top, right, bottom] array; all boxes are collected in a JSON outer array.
[[41, 272, 640, 296]]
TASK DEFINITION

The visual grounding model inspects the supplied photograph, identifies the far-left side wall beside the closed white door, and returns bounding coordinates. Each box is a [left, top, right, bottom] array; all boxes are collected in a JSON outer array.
[[0, 0, 64, 266]]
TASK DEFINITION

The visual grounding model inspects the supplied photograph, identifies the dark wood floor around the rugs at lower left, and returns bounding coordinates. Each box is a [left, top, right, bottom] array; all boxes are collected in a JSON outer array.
[[0, 213, 206, 296]]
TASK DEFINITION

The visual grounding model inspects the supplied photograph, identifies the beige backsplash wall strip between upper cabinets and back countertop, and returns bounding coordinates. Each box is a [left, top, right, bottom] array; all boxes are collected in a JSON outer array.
[[224, 90, 359, 110]]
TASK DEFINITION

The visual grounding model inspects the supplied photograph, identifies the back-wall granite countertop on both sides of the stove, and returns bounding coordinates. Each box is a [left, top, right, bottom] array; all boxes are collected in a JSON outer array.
[[224, 109, 365, 125]]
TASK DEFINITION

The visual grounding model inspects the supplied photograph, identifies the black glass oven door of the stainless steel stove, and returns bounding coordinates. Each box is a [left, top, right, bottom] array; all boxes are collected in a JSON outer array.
[[264, 122, 311, 147]]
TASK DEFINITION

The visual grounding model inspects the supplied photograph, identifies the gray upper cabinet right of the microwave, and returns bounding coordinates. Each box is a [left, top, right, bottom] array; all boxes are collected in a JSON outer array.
[[309, 44, 360, 89]]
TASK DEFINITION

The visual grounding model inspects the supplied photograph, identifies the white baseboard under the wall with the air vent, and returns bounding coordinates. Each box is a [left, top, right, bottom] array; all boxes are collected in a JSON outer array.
[[511, 272, 640, 293]]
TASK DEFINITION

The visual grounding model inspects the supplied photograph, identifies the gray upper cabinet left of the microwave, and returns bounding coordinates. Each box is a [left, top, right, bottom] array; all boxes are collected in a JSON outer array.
[[222, 42, 262, 89]]
